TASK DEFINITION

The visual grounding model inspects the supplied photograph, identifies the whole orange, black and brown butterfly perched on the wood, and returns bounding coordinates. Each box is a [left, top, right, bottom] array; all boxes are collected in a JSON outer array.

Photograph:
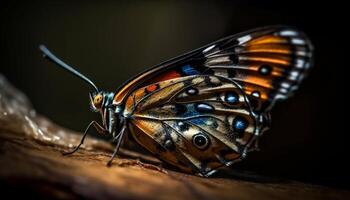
[[39, 26, 313, 177]]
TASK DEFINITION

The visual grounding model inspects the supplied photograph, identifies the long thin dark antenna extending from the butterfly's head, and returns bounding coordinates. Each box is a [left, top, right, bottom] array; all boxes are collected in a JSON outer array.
[[39, 45, 99, 92]]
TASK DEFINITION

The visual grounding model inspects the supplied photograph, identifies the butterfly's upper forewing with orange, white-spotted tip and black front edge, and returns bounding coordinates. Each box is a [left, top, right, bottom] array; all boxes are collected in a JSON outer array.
[[114, 26, 313, 111]]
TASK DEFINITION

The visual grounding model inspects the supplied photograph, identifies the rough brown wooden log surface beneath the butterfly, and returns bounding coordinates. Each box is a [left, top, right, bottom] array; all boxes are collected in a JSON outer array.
[[0, 75, 350, 200]]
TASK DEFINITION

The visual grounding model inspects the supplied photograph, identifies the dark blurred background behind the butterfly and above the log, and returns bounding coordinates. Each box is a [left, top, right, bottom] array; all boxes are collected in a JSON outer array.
[[0, 1, 350, 188]]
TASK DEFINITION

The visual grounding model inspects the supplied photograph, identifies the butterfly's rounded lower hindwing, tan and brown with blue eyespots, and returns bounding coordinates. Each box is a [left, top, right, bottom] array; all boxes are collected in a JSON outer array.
[[126, 75, 262, 175]]
